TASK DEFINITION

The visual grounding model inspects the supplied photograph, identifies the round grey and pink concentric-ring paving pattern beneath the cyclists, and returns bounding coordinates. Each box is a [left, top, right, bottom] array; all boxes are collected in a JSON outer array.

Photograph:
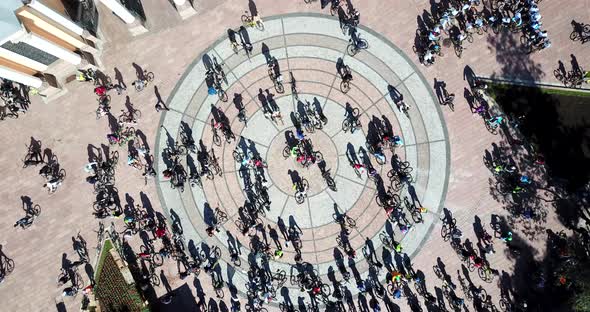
[[156, 14, 450, 302]]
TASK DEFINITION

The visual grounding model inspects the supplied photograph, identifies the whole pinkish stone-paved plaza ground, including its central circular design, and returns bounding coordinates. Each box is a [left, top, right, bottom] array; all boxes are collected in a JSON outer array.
[[0, 0, 590, 311]]
